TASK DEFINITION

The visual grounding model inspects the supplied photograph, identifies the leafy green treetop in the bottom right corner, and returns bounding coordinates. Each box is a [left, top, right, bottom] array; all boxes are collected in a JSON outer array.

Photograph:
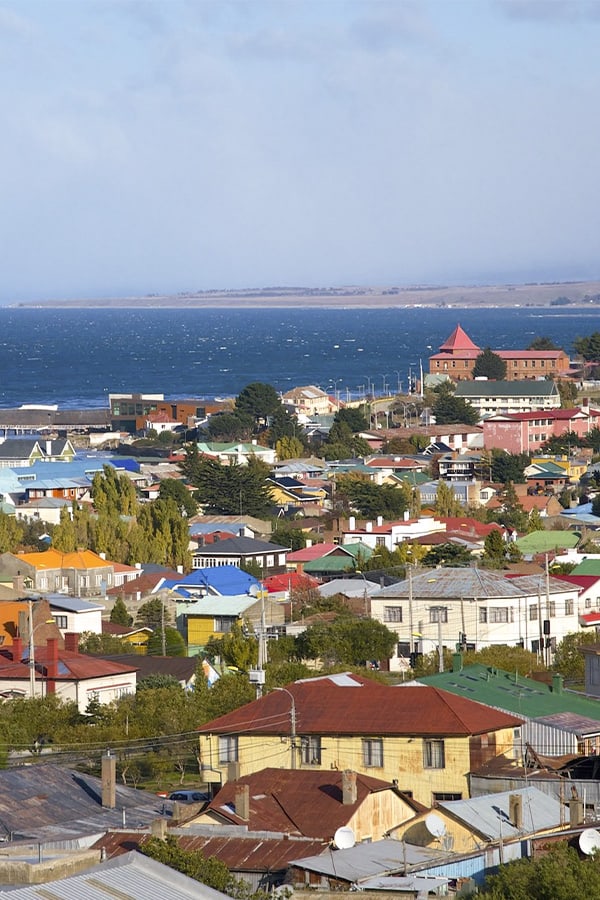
[[477, 842, 600, 900]]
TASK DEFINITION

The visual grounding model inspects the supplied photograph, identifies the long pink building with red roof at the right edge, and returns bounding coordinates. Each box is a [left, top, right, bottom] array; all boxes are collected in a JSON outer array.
[[483, 406, 600, 453]]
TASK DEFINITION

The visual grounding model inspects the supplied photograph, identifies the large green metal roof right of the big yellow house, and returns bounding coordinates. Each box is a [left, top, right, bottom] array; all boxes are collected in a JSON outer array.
[[419, 664, 600, 730]]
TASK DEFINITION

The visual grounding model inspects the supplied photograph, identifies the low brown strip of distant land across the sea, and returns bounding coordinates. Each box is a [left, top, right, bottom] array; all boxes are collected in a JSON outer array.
[[9, 281, 600, 309]]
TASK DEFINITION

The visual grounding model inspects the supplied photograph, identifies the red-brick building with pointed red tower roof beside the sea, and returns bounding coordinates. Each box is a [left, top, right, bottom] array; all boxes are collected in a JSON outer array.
[[429, 325, 570, 381]]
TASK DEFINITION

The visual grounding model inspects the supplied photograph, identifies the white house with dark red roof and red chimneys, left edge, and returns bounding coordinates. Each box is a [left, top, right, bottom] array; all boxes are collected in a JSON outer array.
[[0, 633, 137, 713]]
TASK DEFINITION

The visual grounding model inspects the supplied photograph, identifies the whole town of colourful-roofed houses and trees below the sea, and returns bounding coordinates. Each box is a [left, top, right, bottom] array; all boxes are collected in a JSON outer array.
[[0, 324, 600, 900]]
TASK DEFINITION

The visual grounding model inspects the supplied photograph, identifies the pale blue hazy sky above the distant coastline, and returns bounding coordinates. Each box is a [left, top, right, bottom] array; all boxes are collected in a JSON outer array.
[[0, 0, 600, 304]]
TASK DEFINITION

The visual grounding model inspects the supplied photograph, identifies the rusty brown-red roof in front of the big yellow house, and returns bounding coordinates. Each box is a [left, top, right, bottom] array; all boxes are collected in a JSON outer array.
[[206, 768, 406, 841]]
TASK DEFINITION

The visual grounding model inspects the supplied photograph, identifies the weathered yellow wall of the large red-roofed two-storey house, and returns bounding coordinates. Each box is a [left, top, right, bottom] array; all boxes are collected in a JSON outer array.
[[200, 728, 513, 806]]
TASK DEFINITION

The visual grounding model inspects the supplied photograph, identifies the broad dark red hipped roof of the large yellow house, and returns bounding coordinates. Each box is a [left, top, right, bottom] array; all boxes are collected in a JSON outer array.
[[198, 674, 521, 737]]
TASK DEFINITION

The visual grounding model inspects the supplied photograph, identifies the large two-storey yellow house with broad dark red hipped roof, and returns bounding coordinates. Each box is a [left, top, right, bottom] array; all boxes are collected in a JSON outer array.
[[198, 673, 521, 806]]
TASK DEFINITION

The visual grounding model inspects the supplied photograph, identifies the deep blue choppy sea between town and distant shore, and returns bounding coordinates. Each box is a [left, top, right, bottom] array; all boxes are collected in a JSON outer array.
[[0, 307, 600, 409]]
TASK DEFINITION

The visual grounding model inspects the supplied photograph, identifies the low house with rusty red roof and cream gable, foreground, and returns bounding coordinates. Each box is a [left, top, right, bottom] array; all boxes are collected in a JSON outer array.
[[194, 768, 423, 842]]
